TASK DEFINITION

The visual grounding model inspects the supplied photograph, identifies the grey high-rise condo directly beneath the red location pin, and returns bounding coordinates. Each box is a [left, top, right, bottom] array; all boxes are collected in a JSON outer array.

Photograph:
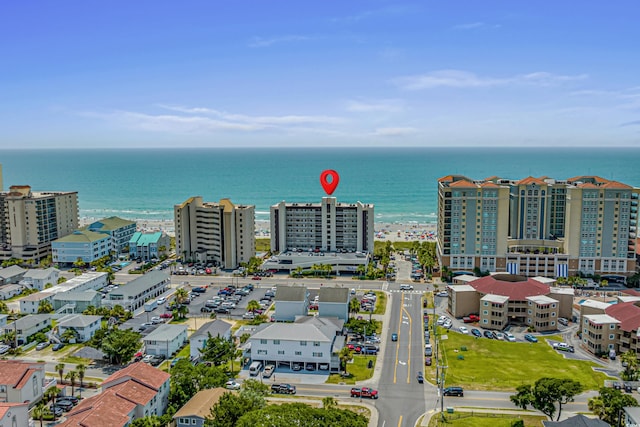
[[271, 197, 374, 253]]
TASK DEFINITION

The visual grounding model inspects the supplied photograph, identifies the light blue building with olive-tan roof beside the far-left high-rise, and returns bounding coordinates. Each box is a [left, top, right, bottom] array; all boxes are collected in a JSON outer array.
[[51, 230, 111, 265]]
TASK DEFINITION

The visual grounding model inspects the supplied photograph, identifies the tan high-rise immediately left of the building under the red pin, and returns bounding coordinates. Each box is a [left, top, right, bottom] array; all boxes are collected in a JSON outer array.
[[173, 196, 256, 268]]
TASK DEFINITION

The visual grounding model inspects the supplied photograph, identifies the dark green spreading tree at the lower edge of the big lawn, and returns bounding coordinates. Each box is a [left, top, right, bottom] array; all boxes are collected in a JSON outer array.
[[510, 378, 582, 420]]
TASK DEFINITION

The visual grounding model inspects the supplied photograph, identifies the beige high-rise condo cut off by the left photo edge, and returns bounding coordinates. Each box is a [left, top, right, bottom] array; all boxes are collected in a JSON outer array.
[[0, 185, 78, 261]]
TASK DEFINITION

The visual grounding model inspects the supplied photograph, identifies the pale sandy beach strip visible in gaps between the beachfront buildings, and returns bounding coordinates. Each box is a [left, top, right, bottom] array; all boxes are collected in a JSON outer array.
[[80, 217, 436, 242]]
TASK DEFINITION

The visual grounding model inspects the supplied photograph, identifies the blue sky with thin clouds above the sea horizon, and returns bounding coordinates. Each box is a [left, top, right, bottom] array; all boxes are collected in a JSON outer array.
[[0, 0, 640, 148]]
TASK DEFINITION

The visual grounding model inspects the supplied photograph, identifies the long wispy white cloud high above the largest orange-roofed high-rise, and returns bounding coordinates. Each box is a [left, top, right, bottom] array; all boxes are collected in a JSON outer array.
[[393, 70, 588, 90]]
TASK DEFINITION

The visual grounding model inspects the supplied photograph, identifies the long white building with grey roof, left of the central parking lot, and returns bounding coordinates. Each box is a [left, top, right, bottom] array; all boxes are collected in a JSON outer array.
[[102, 270, 171, 311]]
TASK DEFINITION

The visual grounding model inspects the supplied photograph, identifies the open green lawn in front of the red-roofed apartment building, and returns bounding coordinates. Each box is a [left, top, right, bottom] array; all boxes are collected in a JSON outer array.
[[438, 328, 610, 391]]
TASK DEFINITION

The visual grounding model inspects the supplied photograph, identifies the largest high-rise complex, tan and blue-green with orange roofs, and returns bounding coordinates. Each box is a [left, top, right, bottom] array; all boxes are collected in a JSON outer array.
[[438, 175, 639, 277]]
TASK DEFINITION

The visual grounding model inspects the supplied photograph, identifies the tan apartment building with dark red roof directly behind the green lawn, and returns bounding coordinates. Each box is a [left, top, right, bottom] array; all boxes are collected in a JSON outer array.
[[447, 274, 574, 332]]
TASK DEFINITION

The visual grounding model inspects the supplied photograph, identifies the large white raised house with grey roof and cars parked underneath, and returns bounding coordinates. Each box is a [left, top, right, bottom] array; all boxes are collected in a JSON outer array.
[[249, 316, 345, 371]]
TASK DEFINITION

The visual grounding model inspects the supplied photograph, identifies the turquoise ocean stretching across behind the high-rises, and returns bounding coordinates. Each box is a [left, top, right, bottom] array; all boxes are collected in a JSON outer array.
[[0, 148, 640, 224]]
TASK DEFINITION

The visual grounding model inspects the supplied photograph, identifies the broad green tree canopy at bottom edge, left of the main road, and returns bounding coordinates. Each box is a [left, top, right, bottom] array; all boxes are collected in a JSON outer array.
[[235, 403, 368, 427]]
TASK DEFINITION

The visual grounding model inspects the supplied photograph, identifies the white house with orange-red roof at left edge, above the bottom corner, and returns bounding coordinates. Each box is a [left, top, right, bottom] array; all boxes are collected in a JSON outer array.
[[0, 360, 45, 408]]
